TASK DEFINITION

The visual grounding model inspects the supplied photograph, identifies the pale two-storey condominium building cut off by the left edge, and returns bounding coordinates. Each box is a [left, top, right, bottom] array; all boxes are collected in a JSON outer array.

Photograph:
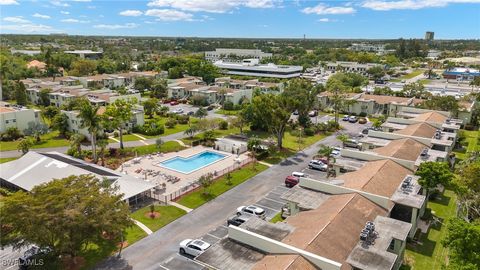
[[0, 102, 42, 133]]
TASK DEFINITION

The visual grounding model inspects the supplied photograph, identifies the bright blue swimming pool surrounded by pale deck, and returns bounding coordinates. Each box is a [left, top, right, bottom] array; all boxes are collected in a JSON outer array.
[[158, 151, 226, 174]]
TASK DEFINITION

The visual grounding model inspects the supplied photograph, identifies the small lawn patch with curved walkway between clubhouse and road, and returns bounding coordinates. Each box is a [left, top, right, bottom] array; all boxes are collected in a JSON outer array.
[[130, 205, 187, 232]]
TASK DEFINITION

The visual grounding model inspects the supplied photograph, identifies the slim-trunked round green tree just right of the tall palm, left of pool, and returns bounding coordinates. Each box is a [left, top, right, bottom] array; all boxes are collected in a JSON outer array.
[[104, 98, 135, 149]]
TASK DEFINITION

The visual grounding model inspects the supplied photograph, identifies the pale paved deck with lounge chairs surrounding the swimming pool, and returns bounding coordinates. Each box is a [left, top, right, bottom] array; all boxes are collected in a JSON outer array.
[[117, 146, 248, 195]]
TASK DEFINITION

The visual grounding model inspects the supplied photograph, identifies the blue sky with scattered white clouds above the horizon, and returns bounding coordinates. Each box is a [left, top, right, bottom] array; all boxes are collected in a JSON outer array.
[[0, 0, 480, 39]]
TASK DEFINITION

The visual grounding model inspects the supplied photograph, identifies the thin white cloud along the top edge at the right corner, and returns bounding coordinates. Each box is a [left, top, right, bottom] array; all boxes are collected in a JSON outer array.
[[362, 0, 480, 11]]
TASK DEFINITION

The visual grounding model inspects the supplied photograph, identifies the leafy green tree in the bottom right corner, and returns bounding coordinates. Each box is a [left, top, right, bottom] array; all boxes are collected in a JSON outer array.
[[442, 218, 480, 270]]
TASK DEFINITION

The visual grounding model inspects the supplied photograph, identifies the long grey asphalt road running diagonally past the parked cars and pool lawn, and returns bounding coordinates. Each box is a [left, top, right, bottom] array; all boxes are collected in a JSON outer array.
[[97, 123, 365, 269]]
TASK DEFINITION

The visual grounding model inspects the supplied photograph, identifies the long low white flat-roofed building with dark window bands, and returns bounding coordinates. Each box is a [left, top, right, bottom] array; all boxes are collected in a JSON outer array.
[[214, 59, 303, 79]]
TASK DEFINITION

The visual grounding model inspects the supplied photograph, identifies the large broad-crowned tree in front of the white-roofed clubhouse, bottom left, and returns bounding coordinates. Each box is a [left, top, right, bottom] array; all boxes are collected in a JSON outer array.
[[0, 175, 133, 262]]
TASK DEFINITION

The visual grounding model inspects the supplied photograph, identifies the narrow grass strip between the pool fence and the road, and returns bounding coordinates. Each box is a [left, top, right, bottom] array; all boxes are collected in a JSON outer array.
[[177, 163, 268, 209]]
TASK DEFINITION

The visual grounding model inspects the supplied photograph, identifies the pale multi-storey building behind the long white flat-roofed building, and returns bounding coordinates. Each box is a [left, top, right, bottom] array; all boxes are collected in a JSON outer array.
[[205, 49, 273, 62]]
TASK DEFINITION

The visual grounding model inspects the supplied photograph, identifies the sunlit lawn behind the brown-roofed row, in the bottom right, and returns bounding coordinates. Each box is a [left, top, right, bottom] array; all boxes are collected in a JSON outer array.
[[405, 189, 456, 270]]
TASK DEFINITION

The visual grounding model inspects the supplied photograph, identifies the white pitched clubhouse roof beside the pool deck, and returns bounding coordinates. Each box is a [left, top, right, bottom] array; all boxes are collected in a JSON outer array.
[[0, 151, 155, 200]]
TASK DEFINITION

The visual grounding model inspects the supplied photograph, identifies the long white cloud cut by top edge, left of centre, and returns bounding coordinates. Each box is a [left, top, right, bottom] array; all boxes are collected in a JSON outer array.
[[147, 0, 281, 13]]
